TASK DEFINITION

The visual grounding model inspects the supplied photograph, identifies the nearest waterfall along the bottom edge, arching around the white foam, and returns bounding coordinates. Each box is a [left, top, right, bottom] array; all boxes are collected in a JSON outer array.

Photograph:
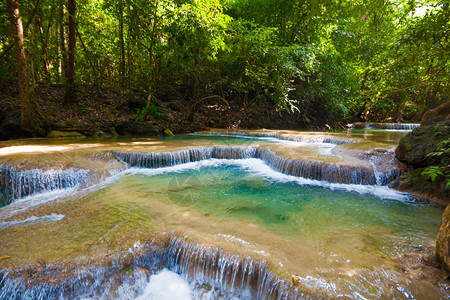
[[0, 235, 305, 300]]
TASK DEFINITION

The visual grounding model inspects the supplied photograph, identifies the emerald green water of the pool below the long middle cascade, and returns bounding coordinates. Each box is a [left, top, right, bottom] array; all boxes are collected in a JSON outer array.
[[118, 159, 442, 256]]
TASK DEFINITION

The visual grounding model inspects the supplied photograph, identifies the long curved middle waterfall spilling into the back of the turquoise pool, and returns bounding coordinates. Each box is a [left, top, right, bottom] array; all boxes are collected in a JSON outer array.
[[113, 147, 398, 185]]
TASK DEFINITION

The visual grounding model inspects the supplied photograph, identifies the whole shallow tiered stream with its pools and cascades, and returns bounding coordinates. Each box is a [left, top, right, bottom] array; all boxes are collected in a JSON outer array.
[[0, 129, 448, 299]]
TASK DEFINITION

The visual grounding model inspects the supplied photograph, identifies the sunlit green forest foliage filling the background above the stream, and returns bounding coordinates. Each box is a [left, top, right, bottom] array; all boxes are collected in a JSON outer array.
[[0, 0, 450, 131]]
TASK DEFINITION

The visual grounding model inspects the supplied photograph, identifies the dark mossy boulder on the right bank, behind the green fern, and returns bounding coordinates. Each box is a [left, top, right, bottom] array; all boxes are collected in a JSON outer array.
[[395, 120, 450, 168]]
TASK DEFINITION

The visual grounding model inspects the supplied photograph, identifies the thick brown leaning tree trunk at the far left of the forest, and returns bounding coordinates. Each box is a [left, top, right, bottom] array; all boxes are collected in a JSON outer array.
[[6, 0, 48, 136]]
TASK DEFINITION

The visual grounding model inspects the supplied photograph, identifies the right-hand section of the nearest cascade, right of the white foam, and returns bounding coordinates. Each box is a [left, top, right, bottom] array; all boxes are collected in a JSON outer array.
[[168, 237, 301, 299]]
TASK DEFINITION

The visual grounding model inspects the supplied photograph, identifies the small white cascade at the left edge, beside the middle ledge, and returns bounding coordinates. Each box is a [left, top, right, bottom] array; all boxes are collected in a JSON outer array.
[[0, 165, 89, 204]]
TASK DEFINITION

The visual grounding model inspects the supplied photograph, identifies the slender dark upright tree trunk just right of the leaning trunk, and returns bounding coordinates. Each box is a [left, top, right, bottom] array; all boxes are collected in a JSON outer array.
[[65, 0, 76, 103]]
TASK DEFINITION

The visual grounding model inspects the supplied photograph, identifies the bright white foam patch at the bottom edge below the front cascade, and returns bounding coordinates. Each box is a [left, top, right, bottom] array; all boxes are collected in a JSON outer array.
[[136, 269, 192, 300]]
